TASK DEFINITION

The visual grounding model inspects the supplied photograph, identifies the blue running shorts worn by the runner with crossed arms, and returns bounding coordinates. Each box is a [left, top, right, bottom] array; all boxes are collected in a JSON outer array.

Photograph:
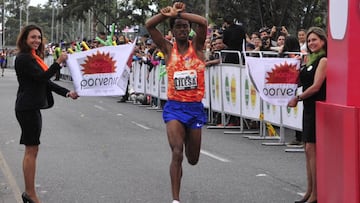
[[163, 100, 207, 129]]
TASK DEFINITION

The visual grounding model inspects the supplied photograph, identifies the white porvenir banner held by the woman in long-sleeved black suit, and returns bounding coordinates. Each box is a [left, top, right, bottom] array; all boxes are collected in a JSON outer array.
[[66, 43, 135, 96]]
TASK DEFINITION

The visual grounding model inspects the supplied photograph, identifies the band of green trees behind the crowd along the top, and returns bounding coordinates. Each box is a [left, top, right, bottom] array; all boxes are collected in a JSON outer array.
[[0, 0, 327, 45]]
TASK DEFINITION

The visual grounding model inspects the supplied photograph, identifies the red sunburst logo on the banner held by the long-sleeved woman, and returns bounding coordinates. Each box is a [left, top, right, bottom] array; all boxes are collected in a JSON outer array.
[[81, 51, 116, 75]]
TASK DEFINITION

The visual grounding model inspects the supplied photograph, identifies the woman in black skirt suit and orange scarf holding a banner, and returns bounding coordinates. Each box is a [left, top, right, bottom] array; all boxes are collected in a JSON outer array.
[[15, 25, 78, 203]]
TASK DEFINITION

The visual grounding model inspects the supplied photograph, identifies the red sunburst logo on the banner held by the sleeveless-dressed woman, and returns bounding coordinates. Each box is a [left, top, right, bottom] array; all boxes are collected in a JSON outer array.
[[266, 62, 299, 84]]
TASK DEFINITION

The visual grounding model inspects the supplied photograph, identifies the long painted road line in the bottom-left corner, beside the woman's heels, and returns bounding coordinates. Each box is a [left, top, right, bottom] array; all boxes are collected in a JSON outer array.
[[0, 151, 23, 203]]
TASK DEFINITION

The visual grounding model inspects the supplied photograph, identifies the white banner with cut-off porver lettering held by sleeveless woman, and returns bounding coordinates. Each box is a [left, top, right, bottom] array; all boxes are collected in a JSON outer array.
[[246, 57, 300, 106]]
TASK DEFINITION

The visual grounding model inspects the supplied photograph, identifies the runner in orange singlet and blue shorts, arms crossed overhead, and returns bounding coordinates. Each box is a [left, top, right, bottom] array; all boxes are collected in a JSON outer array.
[[146, 2, 207, 203]]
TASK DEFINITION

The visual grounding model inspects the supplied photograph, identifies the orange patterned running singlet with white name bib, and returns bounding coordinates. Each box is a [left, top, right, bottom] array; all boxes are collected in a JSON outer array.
[[166, 41, 205, 102]]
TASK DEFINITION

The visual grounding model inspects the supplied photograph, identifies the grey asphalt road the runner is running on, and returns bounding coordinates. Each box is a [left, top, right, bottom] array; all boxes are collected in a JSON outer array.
[[0, 69, 306, 203]]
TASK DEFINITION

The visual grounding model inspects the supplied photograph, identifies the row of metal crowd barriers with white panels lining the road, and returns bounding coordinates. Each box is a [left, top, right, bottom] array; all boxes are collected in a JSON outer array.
[[58, 51, 303, 145]]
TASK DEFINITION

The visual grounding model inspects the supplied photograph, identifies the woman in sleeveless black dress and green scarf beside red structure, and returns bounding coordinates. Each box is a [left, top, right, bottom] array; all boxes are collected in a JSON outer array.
[[288, 27, 327, 203]]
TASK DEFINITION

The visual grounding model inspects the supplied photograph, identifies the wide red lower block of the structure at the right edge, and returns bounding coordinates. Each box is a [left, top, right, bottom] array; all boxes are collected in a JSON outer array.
[[316, 102, 360, 203]]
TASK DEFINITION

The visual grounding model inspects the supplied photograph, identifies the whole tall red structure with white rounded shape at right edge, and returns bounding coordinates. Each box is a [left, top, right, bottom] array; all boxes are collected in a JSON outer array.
[[316, 0, 360, 203]]
